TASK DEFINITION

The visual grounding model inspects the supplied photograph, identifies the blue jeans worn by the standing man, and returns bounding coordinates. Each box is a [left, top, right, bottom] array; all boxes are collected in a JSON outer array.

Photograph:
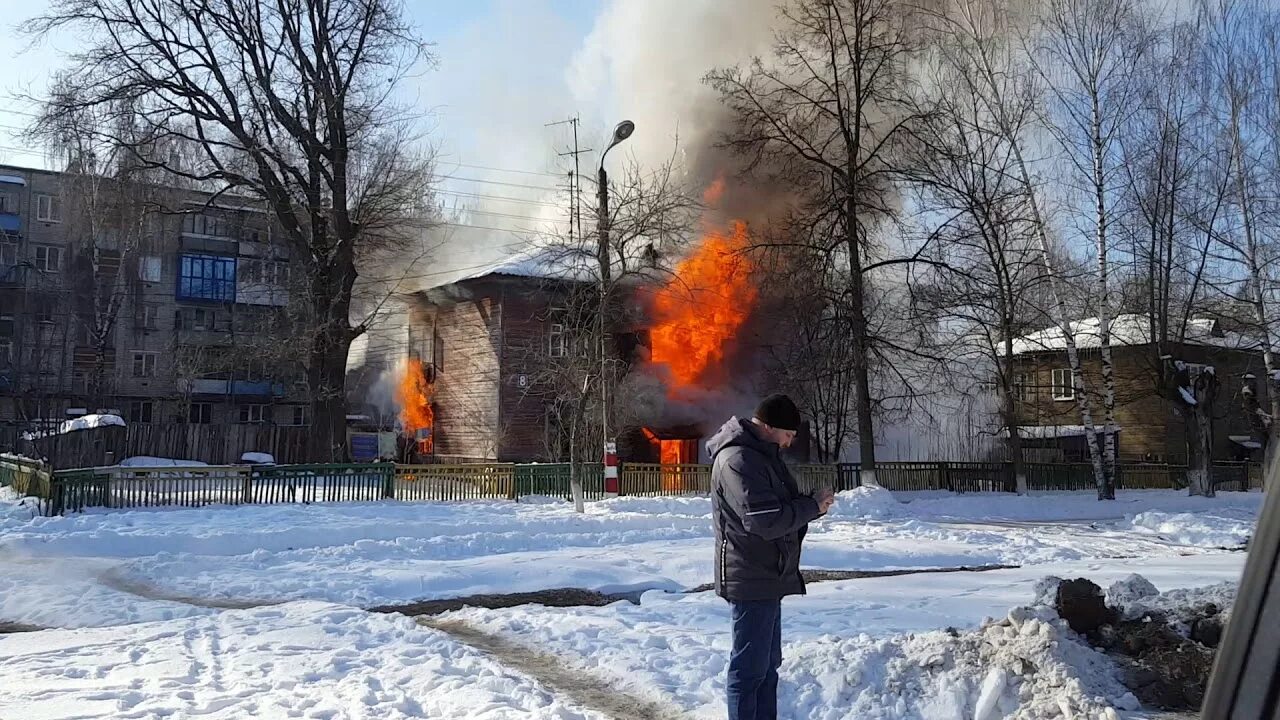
[[728, 600, 782, 720]]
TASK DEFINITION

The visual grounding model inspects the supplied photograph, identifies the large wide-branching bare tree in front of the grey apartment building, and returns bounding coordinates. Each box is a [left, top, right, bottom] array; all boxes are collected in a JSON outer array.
[[23, 0, 429, 460]]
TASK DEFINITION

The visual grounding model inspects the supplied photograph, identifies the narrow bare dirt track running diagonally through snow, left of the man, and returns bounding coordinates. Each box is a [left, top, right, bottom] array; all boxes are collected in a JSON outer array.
[[416, 618, 686, 720]]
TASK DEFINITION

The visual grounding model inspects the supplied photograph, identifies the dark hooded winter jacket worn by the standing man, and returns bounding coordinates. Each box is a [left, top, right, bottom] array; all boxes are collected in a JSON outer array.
[[707, 418, 820, 602]]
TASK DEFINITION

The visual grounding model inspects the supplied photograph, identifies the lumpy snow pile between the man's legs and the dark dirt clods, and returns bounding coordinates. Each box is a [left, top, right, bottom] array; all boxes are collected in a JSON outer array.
[[780, 607, 1138, 720]]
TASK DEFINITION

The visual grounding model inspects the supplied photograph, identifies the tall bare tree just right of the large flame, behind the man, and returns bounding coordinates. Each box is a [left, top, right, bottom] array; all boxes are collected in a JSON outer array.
[[707, 0, 920, 483]]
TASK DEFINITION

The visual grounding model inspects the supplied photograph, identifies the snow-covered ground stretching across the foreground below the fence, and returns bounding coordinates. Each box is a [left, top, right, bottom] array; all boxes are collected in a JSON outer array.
[[0, 488, 1262, 719]]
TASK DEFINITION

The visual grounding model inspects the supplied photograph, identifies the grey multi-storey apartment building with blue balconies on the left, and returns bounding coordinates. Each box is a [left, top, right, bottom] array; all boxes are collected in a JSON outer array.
[[0, 165, 308, 429]]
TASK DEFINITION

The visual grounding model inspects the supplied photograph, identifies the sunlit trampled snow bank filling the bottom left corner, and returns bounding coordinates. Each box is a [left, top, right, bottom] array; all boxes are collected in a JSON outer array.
[[0, 602, 604, 720]]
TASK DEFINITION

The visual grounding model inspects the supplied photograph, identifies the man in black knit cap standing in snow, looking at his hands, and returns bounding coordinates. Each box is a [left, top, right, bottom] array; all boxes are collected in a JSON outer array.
[[707, 395, 835, 720]]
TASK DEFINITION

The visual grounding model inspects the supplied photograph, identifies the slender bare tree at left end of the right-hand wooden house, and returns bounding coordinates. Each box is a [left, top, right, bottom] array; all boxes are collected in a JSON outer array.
[[910, 47, 1044, 493]]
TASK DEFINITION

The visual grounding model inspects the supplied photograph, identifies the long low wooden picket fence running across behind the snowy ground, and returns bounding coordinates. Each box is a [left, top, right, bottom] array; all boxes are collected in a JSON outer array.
[[20, 456, 1262, 515]]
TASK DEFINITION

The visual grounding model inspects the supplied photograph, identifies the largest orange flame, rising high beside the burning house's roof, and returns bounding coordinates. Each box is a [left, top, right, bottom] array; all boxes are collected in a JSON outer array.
[[649, 219, 756, 391]]
